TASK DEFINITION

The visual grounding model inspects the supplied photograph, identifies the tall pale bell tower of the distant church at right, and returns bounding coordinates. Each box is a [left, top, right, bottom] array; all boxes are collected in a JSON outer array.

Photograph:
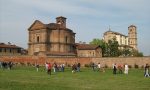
[[128, 25, 138, 50]]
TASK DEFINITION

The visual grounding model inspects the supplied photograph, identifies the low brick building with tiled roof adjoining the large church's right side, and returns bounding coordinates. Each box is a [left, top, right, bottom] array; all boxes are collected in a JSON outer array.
[[76, 44, 102, 57]]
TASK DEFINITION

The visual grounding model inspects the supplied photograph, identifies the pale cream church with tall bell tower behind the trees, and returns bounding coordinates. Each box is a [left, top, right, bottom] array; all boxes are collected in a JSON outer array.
[[103, 25, 138, 50]]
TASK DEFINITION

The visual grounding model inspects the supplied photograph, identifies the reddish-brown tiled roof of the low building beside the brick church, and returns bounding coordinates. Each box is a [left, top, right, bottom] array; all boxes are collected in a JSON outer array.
[[76, 44, 100, 50]]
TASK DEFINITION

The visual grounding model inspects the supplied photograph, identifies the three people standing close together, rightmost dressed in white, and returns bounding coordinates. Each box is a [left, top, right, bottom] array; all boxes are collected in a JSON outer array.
[[113, 64, 129, 74]]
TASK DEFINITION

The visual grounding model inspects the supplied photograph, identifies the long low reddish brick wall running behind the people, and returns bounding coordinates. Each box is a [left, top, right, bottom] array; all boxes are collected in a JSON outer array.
[[0, 56, 150, 67]]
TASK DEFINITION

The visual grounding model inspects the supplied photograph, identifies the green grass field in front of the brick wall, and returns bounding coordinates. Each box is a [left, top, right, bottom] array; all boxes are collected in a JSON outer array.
[[0, 66, 150, 90]]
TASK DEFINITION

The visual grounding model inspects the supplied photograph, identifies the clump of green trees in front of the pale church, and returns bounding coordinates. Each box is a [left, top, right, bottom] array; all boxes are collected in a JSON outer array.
[[90, 38, 143, 57]]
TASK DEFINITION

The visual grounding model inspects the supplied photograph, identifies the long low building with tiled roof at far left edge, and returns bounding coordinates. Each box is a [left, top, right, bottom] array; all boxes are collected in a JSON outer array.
[[0, 43, 22, 56]]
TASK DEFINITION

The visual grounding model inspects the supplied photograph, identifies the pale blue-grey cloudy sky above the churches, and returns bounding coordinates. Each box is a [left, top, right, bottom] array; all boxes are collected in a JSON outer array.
[[0, 0, 150, 55]]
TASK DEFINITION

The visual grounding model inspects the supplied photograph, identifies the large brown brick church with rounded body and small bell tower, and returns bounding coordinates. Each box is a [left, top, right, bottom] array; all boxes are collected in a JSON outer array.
[[28, 16, 76, 56]]
